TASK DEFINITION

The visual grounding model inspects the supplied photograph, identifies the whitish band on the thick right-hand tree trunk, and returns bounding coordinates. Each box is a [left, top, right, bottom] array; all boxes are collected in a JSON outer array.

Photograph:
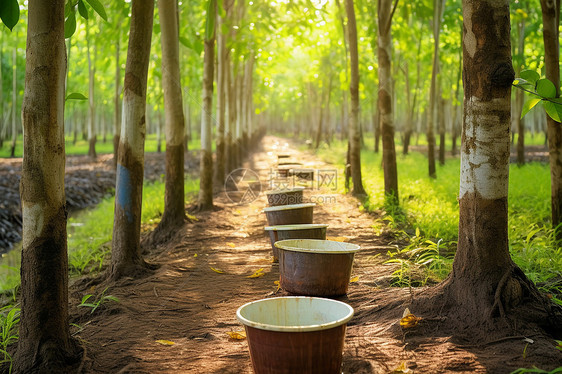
[[459, 97, 510, 199]]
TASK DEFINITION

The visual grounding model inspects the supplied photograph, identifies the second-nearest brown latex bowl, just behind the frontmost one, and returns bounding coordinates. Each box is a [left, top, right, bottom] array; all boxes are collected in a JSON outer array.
[[275, 239, 360, 296]]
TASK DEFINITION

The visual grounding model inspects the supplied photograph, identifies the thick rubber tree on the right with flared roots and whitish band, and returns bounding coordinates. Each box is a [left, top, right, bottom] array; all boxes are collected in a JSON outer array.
[[427, 0, 562, 334]]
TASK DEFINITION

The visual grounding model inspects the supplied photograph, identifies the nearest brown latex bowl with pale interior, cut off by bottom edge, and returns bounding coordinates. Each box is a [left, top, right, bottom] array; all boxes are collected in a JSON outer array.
[[236, 296, 353, 374]]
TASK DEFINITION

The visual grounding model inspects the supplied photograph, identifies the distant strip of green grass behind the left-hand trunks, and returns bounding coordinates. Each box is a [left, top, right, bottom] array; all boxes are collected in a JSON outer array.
[[0, 134, 201, 158]]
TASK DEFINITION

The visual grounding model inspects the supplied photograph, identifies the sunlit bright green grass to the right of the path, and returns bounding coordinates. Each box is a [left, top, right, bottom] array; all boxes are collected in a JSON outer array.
[[318, 141, 562, 301]]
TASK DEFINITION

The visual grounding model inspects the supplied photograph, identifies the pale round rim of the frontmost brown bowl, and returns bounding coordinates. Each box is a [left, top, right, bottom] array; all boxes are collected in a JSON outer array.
[[236, 296, 355, 332]]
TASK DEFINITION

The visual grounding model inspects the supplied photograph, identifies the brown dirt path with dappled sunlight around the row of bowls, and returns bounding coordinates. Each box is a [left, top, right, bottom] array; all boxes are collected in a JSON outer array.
[[71, 137, 552, 374]]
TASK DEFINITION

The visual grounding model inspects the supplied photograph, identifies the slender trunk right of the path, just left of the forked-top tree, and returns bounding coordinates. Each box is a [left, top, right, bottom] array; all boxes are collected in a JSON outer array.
[[345, 0, 367, 196]]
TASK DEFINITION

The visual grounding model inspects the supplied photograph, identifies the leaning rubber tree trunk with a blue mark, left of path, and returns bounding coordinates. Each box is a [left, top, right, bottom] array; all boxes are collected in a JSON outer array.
[[108, 0, 154, 280]]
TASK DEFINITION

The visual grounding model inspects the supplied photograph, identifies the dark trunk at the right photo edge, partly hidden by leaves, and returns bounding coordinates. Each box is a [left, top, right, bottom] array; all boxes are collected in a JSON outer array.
[[541, 0, 562, 240]]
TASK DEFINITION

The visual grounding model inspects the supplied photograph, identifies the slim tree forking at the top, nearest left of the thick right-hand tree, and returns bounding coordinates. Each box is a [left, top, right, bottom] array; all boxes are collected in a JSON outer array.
[[377, 0, 399, 204]]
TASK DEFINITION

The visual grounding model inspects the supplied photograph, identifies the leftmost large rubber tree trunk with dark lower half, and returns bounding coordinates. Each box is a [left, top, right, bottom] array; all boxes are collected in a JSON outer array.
[[14, 0, 81, 373]]
